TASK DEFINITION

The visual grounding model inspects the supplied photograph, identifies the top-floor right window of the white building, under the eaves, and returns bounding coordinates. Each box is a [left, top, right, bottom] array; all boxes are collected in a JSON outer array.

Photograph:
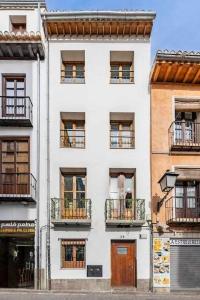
[[110, 51, 134, 83]]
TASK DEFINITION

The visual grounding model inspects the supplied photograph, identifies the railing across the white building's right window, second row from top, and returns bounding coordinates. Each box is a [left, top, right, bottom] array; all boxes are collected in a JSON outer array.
[[110, 130, 135, 149]]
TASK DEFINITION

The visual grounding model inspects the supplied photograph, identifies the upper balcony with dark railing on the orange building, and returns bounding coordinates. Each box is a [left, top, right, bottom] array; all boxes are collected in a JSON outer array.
[[169, 121, 200, 151]]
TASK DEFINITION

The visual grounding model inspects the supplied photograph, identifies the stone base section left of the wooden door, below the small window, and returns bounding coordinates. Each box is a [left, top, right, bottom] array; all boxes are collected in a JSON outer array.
[[51, 279, 111, 291]]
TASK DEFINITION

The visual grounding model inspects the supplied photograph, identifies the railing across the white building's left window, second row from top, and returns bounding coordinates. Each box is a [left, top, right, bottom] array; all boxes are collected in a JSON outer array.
[[60, 129, 85, 149]]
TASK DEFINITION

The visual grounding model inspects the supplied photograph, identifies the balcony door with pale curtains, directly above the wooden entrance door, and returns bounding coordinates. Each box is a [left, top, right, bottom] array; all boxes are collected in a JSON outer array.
[[108, 174, 135, 219]]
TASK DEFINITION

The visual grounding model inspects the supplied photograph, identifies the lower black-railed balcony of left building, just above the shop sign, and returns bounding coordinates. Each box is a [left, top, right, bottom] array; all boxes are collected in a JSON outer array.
[[0, 173, 36, 203]]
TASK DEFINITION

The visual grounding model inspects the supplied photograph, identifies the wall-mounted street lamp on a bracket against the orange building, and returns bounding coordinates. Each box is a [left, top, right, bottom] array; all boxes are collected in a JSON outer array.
[[157, 170, 179, 211]]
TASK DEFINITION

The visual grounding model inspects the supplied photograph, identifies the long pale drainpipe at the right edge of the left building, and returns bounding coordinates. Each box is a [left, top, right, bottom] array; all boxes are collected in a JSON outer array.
[[36, 3, 40, 289]]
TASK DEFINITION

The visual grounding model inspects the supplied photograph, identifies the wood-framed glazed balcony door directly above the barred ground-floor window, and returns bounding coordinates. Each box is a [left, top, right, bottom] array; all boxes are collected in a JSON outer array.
[[61, 174, 88, 219]]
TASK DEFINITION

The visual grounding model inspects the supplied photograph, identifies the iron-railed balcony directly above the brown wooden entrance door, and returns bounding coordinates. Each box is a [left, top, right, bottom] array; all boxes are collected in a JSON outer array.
[[105, 199, 145, 226]]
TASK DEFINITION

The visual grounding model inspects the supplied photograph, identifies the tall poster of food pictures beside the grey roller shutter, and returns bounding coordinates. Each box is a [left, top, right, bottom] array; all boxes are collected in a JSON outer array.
[[153, 238, 170, 287]]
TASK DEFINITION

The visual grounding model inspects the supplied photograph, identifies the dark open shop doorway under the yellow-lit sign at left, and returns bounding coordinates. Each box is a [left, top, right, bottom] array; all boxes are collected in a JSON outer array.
[[0, 237, 35, 288]]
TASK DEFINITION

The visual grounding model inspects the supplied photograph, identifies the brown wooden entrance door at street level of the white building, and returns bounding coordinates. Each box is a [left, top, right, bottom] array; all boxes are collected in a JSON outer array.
[[111, 241, 136, 287]]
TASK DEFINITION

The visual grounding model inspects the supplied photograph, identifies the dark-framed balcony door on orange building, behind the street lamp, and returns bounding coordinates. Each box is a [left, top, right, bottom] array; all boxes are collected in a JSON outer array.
[[175, 181, 200, 218]]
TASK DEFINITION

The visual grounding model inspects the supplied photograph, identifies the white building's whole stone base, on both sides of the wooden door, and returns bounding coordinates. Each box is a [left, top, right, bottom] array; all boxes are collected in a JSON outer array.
[[51, 279, 150, 292]]
